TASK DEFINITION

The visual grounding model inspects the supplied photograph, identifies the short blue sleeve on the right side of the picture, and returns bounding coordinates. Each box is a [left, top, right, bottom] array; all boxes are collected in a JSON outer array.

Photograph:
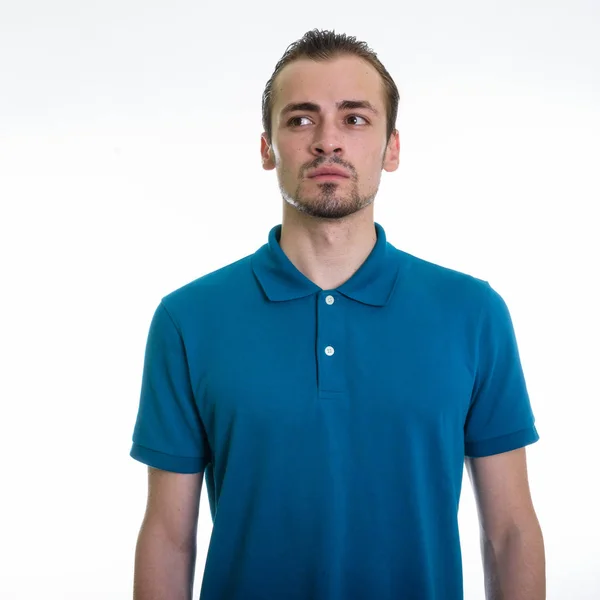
[[464, 282, 539, 457]]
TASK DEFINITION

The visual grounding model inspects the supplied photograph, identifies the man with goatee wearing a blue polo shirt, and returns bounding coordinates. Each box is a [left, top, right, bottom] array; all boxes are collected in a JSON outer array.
[[131, 30, 545, 600]]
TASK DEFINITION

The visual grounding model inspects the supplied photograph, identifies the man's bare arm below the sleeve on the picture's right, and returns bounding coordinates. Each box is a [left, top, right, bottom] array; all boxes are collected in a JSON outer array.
[[465, 447, 546, 600]]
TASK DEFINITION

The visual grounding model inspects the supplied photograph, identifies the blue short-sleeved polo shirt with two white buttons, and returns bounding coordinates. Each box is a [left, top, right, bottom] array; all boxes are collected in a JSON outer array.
[[131, 223, 539, 600]]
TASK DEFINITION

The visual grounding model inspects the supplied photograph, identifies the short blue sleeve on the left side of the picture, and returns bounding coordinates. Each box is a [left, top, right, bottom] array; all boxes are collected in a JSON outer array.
[[130, 302, 210, 473]]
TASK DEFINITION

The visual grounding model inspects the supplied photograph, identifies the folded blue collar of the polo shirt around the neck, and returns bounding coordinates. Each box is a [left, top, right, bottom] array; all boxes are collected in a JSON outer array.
[[251, 223, 400, 306]]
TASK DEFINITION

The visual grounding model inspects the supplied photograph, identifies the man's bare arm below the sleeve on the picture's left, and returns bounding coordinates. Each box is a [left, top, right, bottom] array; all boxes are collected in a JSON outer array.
[[133, 467, 204, 600]]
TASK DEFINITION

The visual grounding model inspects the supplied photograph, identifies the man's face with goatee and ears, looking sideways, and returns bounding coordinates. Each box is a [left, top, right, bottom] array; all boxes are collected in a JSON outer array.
[[261, 56, 399, 219]]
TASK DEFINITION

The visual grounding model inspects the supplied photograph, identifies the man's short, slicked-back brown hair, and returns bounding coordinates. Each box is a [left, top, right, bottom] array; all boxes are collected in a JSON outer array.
[[262, 29, 400, 145]]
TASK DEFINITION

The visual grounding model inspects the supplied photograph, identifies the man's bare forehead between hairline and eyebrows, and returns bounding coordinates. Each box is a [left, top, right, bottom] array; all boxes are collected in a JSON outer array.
[[273, 56, 384, 116]]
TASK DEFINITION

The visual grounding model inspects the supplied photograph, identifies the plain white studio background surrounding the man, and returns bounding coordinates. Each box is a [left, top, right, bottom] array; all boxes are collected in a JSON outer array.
[[0, 0, 600, 600]]
